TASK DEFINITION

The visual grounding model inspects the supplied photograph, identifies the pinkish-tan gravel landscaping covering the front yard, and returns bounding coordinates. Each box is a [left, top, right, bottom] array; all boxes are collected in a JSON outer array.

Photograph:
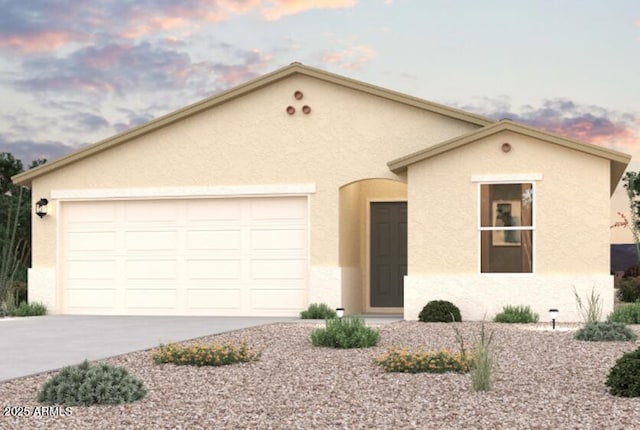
[[0, 321, 640, 429]]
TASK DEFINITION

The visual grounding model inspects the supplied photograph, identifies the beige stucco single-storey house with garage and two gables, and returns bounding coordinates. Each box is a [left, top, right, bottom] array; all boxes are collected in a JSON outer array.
[[14, 63, 630, 321]]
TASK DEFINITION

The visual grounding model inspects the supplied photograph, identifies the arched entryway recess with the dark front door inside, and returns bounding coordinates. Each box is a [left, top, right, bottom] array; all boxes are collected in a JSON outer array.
[[340, 179, 407, 314]]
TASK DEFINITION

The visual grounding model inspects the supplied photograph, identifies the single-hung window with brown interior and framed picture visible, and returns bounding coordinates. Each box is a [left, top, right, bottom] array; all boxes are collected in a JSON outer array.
[[480, 183, 535, 273]]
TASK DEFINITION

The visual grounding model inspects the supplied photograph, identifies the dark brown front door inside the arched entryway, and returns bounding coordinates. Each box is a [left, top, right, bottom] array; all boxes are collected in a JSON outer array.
[[370, 202, 407, 307]]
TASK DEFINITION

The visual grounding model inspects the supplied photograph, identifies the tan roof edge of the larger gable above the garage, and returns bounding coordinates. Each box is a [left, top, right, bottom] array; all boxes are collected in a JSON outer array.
[[12, 62, 494, 185]]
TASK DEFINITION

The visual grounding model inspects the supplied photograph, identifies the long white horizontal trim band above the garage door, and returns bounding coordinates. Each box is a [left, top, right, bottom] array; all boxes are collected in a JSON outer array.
[[51, 184, 316, 200]]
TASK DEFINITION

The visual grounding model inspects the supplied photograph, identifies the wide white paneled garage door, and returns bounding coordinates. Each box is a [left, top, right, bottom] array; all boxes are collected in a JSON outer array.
[[61, 197, 309, 316]]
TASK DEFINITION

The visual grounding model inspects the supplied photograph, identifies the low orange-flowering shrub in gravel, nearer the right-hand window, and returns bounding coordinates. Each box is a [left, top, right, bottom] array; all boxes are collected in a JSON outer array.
[[375, 348, 472, 373]]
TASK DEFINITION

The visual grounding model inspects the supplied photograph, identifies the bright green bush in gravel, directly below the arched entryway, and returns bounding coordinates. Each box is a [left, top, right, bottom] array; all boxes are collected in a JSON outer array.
[[310, 317, 380, 348]]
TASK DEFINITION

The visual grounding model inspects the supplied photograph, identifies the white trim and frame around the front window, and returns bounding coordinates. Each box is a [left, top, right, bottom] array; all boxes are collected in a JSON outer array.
[[478, 181, 542, 278]]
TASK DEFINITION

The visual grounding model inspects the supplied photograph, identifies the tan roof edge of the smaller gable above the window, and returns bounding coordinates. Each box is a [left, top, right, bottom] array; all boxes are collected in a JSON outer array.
[[387, 119, 631, 194]]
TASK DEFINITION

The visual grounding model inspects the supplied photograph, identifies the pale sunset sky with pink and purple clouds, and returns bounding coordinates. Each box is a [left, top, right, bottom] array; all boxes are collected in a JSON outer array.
[[0, 0, 640, 243]]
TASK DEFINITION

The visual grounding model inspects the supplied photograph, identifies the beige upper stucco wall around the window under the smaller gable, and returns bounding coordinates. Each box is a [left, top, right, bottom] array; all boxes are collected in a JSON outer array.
[[408, 132, 609, 275]]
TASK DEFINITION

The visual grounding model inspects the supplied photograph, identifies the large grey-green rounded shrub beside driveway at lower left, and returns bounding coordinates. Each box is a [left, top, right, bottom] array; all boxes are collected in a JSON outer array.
[[38, 360, 147, 406]]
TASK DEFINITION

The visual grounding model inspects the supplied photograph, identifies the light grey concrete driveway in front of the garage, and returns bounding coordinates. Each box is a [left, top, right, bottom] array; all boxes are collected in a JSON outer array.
[[0, 315, 297, 382]]
